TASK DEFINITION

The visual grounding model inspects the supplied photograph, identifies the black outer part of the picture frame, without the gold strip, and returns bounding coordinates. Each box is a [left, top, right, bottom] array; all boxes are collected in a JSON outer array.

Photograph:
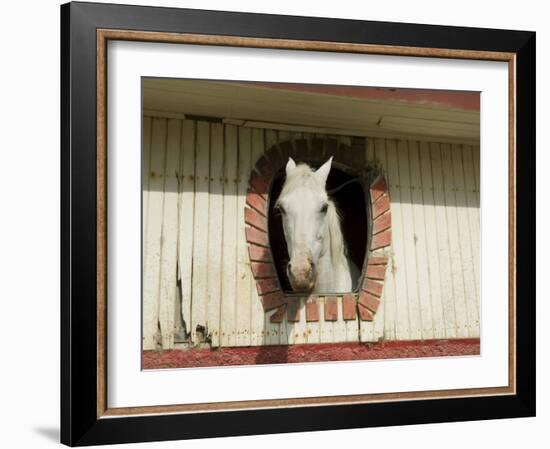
[[61, 3, 535, 446]]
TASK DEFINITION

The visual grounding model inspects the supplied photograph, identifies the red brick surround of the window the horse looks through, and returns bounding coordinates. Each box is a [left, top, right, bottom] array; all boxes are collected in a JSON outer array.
[[244, 138, 391, 322]]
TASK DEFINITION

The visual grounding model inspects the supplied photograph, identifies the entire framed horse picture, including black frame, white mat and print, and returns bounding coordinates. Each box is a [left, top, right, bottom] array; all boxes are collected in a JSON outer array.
[[61, 3, 535, 445]]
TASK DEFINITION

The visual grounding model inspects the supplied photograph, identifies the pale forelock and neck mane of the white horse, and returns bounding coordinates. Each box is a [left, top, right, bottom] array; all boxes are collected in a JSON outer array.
[[275, 164, 347, 265]]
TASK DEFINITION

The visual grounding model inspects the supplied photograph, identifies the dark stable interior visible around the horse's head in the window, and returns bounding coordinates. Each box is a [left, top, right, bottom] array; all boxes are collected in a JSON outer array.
[[268, 167, 368, 293]]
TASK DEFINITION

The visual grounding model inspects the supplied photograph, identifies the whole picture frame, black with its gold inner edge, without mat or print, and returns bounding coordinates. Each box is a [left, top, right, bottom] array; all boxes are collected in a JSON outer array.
[[61, 2, 536, 446]]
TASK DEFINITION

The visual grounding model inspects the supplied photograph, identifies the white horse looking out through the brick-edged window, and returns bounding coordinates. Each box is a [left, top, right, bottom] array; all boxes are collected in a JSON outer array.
[[275, 157, 359, 293]]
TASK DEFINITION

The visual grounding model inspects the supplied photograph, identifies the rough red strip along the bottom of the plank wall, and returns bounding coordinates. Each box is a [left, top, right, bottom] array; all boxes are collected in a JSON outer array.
[[143, 338, 480, 369]]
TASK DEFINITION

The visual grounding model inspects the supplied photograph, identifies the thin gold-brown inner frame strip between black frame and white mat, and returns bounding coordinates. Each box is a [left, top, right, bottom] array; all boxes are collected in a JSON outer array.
[[96, 29, 516, 418]]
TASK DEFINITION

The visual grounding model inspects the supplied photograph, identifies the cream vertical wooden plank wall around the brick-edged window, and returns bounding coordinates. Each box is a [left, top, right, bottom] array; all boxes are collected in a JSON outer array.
[[142, 117, 480, 349]]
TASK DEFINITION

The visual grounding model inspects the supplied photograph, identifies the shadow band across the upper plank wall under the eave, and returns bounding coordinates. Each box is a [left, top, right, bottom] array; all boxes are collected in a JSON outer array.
[[142, 117, 479, 211]]
